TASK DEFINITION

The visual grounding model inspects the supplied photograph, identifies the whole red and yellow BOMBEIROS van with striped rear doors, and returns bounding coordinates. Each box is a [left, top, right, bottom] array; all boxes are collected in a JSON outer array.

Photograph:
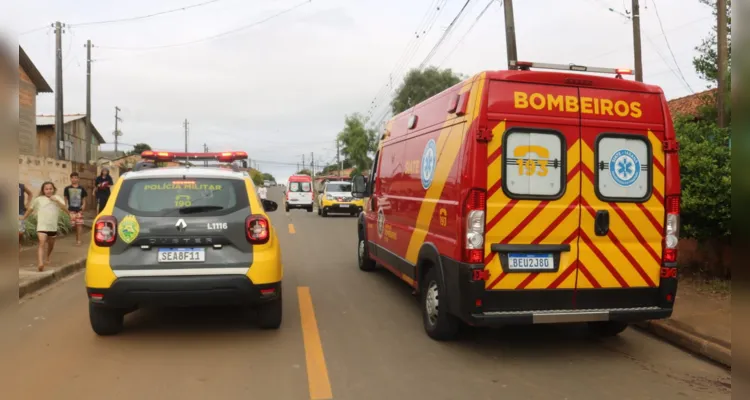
[[353, 62, 680, 340]]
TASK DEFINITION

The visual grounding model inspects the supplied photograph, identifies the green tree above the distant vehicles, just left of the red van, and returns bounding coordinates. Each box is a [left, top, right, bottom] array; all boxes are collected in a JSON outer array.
[[338, 113, 378, 170]]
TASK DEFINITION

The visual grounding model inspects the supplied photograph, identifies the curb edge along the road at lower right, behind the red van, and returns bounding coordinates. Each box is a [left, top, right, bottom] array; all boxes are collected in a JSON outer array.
[[633, 320, 732, 369]]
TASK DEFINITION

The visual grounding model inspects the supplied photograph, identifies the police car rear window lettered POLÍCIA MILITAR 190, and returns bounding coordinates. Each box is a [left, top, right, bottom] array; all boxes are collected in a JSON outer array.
[[116, 178, 248, 216]]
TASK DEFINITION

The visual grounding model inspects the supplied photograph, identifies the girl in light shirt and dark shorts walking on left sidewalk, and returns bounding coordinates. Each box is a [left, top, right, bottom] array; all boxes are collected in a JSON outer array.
[[23, 182, 67, 271]]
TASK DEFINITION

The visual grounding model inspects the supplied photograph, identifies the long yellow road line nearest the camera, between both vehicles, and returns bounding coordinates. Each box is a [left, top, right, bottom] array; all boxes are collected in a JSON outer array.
[[297, 286, 333, 400]]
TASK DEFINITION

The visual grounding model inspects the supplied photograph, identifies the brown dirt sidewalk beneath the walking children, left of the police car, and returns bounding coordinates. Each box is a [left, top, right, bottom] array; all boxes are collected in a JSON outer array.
[[18, 229, 91, 299]]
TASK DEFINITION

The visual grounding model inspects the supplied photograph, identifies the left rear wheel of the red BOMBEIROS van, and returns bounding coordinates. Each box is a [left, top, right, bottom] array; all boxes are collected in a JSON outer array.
[[421, 268, 460, 340]]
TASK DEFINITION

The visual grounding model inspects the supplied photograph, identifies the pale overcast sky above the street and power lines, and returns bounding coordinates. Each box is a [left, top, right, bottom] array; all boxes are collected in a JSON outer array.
[[10, 0, 714, 180]]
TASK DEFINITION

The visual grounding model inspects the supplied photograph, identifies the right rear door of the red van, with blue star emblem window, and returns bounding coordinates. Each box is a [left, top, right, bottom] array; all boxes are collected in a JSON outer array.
[[576, 88, 665, 309]]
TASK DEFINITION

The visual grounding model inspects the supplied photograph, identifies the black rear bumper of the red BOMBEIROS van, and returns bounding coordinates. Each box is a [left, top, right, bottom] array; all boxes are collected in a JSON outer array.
[[442, 257, 677, 326]]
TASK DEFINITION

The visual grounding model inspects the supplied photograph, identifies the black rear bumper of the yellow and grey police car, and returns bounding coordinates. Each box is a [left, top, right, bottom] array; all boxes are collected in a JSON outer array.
[[86, 275, 281, 309]]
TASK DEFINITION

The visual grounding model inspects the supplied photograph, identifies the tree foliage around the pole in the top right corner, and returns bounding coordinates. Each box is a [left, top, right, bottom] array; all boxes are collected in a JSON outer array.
[[693, 0, 732, 84]]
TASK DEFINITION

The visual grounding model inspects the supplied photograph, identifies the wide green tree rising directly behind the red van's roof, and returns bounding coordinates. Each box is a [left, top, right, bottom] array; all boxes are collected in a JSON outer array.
[[391, 67, 461, 115]]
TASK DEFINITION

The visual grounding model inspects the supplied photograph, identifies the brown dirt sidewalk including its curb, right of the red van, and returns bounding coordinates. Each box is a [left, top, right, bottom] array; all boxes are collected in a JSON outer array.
[[637, 278, 732, 368]]
